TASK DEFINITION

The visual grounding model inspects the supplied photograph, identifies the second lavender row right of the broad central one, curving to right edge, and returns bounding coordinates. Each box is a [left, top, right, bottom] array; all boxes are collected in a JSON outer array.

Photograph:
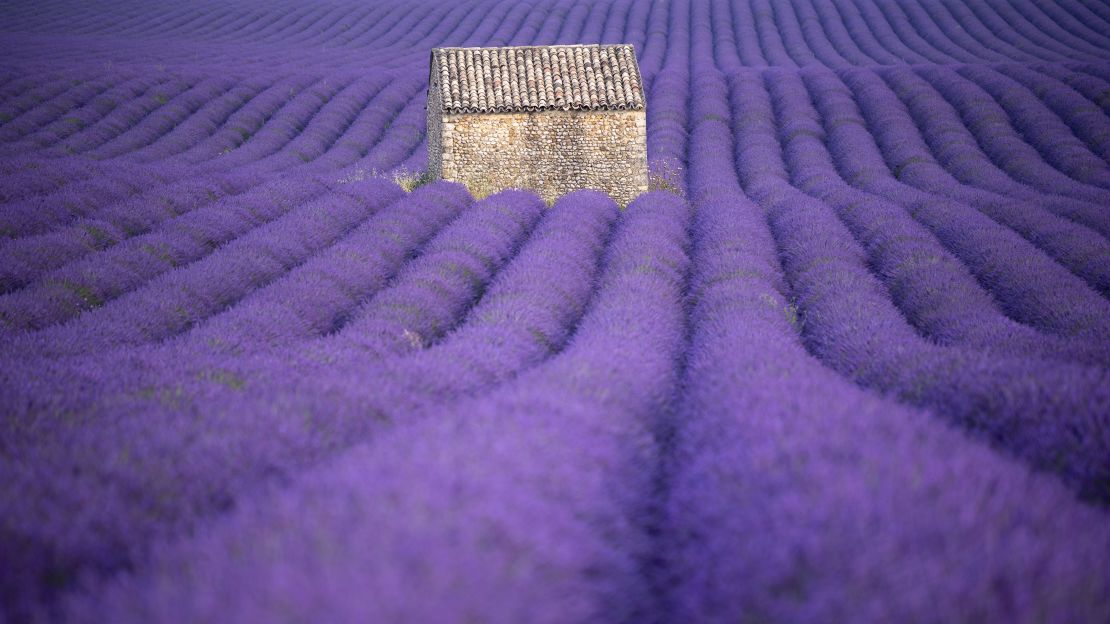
[[722, 68, 1110, 363]]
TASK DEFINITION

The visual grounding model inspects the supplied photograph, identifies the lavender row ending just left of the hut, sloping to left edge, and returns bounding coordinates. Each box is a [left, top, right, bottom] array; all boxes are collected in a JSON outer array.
[[6, 175, 400, 355]]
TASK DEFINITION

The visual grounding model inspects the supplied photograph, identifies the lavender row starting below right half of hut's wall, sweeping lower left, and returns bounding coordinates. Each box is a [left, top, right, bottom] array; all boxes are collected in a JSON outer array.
[[3, 186, 626, 612]]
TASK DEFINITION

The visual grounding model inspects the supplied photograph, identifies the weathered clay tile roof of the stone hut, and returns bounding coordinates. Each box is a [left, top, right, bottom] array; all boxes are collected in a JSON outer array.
[[428, 44, 644, 113]]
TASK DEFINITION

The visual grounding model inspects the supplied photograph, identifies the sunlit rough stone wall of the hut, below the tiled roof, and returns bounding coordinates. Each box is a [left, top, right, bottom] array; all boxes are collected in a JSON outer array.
[[428, 110, 647, 205]]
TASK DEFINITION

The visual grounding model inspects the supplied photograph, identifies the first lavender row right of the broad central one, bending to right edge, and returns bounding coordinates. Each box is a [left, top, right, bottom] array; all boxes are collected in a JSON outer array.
[[739, 68, 1110, 497]]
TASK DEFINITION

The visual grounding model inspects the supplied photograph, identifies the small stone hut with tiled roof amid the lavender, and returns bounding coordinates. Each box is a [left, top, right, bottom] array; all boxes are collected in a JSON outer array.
[[427, 44, 647, 205]]
